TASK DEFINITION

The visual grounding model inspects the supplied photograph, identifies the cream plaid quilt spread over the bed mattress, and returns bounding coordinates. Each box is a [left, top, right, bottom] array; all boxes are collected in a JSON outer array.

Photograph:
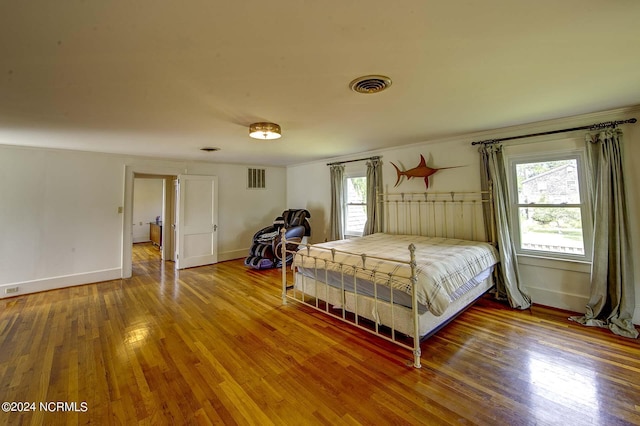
[[293, 233, 498, 315]]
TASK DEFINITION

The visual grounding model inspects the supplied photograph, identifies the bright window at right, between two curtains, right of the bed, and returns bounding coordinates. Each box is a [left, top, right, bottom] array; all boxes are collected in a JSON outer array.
[[510, 151, 591, 260]]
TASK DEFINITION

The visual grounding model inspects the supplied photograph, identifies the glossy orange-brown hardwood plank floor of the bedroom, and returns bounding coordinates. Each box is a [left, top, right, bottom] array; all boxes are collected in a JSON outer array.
[[0, 245, 640, 426]]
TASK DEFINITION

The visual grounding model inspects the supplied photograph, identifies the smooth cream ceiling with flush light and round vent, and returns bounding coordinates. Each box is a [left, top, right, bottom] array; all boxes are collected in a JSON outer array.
[[0, 0, 640, 165]]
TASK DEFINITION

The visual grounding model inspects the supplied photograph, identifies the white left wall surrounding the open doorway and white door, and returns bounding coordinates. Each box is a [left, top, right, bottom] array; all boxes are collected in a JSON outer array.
[[0, 146, 286, 298]]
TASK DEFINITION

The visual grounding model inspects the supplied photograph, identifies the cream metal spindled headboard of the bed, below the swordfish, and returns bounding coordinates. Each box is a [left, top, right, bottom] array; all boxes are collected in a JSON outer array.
[[378, 190, 495, 242]]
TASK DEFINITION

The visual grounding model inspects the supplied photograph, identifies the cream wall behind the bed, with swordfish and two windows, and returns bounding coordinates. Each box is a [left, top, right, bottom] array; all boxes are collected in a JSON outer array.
[[287, 107, 640, 323]]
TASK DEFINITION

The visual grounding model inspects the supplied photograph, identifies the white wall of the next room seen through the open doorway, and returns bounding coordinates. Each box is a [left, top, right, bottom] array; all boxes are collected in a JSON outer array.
[[133, 178, 164, 243]]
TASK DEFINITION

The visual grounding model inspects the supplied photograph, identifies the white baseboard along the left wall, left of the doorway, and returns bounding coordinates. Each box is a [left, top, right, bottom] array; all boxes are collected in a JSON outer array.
[[0, 268, 122, 299]]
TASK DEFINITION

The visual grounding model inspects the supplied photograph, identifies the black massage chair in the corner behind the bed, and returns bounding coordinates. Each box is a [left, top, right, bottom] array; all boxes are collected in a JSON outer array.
[[244, 209, 311, 269]]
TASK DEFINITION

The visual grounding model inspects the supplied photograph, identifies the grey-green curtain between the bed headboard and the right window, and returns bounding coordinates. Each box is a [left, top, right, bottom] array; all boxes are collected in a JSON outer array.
[[480, 145, 531, 309]]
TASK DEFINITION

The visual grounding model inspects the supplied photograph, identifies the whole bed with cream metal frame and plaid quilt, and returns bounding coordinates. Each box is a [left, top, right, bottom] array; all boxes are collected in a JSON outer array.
[[282, 192, 498, 368]]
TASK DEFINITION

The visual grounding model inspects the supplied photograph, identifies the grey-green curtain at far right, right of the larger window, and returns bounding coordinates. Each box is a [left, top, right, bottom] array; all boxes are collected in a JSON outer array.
[[571, 129, 638, 338]]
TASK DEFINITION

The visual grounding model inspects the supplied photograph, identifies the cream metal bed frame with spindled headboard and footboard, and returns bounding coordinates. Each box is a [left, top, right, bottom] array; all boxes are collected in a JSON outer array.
[[281, 190, 495, 368]]
